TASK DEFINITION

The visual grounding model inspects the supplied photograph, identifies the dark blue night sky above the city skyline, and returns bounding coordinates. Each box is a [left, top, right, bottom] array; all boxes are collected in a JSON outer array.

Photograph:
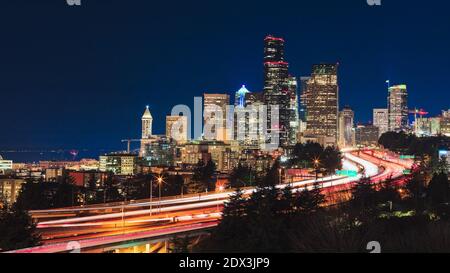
[[0, 0, 450, 149]]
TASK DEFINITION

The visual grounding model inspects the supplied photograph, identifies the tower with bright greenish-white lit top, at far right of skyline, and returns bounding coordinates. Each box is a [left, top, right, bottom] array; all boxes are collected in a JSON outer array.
[[388, 84, 408, 131]]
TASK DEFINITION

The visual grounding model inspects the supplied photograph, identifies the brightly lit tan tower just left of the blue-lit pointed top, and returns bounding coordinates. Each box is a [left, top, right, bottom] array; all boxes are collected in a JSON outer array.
[[203, 94, 230, 141]]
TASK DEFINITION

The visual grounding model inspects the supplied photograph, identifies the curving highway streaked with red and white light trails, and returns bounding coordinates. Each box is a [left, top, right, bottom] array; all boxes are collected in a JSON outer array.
[[5, 152, 412, 253]]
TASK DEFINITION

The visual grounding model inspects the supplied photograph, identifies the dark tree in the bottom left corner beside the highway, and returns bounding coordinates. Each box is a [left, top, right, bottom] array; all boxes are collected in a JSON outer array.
[[0, 203, 41, 251]]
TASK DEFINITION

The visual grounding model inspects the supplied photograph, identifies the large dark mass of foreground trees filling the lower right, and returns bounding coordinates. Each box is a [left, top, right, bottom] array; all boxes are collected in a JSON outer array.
[[192, 163, 450, 253]]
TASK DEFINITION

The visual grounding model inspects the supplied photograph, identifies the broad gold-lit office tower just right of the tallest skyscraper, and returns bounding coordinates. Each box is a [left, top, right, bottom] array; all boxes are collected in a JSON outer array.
[[302, 64, 339, 146]]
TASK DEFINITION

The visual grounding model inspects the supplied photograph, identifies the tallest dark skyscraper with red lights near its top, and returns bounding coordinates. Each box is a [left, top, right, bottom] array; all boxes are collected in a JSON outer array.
[[264, 35, 292, 147]]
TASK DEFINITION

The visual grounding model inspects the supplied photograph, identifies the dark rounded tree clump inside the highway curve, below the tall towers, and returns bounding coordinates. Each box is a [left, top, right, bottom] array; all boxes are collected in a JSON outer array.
[[290, 142, 342, 174]]
